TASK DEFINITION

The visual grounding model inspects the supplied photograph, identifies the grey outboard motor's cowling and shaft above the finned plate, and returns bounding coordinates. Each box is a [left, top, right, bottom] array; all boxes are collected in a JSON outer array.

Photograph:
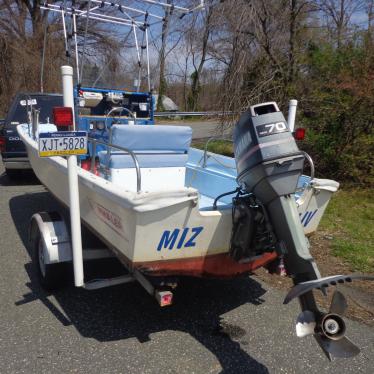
[[234, 102, 320, 283]]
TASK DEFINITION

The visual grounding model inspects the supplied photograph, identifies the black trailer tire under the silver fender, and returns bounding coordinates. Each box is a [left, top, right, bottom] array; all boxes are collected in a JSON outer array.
[[34, 232, 67, 291]]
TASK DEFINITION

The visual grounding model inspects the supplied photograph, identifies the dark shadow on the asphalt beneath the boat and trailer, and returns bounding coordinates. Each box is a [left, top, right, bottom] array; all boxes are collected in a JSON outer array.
[[9, 192, 268, 373]]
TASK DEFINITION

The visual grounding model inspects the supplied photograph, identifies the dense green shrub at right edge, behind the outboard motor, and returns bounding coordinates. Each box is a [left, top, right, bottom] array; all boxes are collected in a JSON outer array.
[[299, 46, 374, 186]]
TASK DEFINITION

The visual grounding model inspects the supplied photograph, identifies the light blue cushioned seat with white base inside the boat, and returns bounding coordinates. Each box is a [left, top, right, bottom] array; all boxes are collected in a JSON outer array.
[[98, 125, 192, 192]]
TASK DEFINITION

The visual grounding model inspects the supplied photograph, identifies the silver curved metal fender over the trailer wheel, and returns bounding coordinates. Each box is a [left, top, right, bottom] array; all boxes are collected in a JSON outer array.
[[29, 212, 73, 264]]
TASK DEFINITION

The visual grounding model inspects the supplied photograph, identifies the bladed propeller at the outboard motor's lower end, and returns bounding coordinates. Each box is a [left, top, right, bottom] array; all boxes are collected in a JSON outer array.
[[296, 290, 360, 360]]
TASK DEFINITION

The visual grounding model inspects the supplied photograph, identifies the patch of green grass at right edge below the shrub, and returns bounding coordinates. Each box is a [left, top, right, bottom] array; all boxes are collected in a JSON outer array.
[[320, 189, 374, 273]]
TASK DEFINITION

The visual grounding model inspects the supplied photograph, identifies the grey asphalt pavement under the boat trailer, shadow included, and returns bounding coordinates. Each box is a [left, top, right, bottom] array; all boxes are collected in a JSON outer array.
[[0, 166, 374, 374]]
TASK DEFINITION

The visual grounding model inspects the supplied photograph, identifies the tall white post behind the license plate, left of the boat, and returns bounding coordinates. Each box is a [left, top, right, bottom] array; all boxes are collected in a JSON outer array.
[[61, 66, 84, 287]]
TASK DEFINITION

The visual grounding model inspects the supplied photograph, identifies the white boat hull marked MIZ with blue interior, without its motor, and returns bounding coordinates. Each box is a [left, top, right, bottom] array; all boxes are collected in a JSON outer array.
[[19, 117, 338, 277]]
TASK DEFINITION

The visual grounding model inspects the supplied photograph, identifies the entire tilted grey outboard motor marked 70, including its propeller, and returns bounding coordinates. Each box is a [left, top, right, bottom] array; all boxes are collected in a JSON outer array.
[[230, 102, 373, 359]]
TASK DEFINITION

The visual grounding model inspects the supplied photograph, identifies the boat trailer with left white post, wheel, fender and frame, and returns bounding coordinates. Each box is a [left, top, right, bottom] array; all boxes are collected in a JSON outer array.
[[29, 66, 175, 306]]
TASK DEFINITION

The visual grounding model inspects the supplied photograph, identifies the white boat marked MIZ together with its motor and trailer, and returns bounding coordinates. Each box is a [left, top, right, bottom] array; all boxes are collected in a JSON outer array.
[[18, 3, 369, 358]]
